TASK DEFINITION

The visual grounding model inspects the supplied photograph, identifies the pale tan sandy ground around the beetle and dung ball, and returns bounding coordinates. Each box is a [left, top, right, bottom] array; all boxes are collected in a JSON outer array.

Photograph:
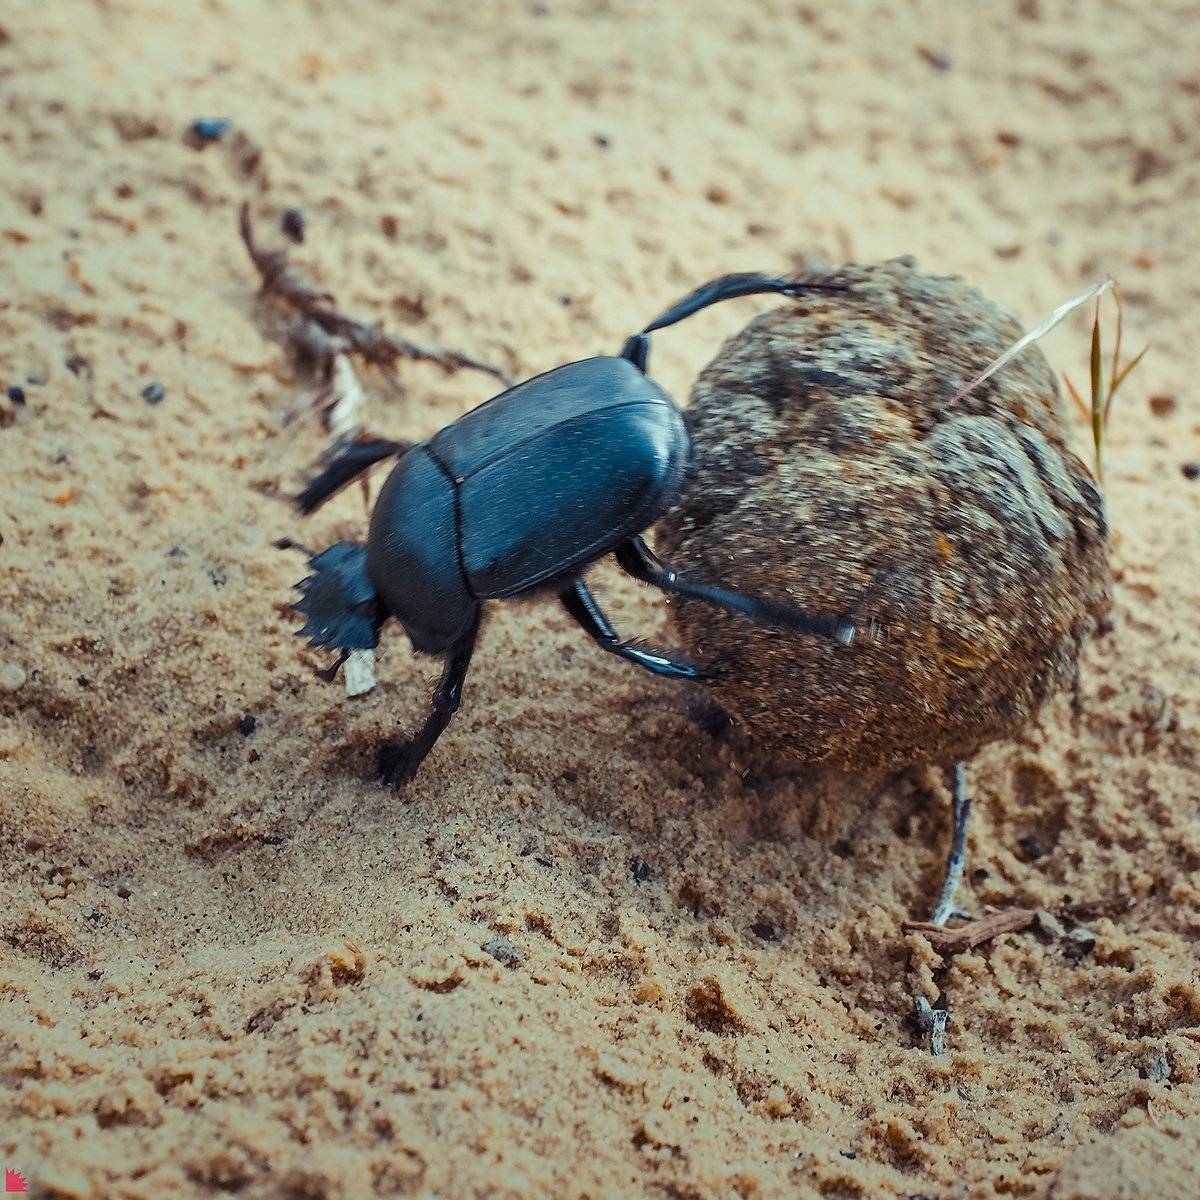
[[0, 0, 1200, 1200]]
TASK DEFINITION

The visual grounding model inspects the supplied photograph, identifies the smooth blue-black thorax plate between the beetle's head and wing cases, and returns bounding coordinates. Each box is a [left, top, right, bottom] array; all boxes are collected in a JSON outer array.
[[367, 445, 476, 654]]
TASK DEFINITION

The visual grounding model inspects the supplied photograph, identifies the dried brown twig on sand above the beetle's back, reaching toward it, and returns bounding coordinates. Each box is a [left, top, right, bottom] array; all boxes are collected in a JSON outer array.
[[239, 203, 511, 386]]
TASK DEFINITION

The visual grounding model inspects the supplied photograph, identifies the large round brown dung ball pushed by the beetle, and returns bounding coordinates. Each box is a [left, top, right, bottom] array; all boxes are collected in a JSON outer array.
[[656, 259, 1111, 772]]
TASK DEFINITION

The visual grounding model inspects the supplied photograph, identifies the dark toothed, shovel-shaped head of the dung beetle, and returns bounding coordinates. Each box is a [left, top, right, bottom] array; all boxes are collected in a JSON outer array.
[[293, 541, 386, 650]]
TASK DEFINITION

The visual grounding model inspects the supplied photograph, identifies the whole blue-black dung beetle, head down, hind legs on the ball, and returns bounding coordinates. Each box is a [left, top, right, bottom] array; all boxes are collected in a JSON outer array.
[[295, 274, 854, 786]]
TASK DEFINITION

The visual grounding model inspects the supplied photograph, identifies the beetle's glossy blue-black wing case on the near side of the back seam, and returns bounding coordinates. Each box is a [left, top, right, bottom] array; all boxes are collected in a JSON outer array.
[[458, 395, 688, 599]]
